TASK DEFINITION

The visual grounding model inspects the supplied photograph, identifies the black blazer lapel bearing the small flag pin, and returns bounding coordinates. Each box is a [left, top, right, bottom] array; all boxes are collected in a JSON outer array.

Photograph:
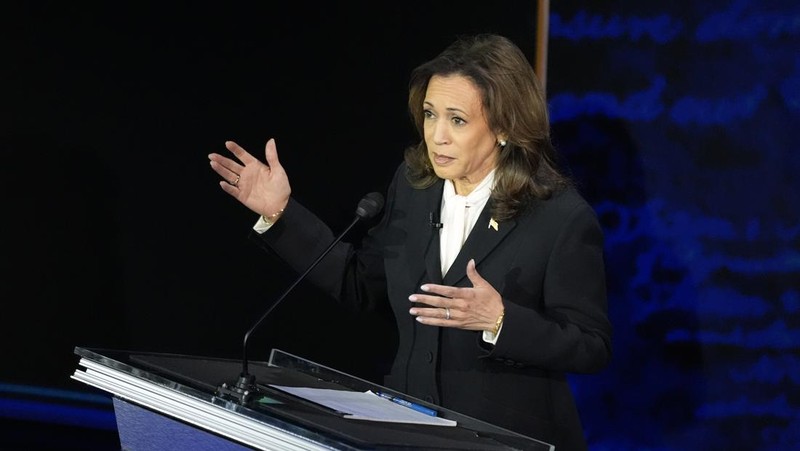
[[437, 199, 517, 286]]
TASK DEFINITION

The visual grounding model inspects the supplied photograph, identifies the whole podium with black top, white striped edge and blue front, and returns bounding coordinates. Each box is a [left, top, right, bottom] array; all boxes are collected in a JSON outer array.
[[71, 347, 555, 451]]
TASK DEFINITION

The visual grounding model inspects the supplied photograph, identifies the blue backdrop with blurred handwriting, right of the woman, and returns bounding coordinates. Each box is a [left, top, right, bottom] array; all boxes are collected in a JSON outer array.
[[548, 0, 800, 450]]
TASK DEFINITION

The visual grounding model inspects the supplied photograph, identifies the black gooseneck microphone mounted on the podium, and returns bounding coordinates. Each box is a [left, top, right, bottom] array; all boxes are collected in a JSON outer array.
[[217, 193, 383, 404]]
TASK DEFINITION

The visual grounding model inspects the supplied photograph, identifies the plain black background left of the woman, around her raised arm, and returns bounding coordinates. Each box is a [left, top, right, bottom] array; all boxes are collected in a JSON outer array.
[[2, 2, 535, 383]]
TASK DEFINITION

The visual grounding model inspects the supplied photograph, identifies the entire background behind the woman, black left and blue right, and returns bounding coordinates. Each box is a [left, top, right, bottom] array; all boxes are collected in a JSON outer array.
[[0, 0, 800, 450]]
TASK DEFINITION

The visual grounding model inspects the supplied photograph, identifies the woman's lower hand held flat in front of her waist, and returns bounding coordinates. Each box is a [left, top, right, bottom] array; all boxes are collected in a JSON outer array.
[[408, 260, 503, 331]]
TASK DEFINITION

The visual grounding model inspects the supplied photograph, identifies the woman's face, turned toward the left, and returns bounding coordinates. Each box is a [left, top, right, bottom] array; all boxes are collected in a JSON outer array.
[[423, 75, 498, 196]]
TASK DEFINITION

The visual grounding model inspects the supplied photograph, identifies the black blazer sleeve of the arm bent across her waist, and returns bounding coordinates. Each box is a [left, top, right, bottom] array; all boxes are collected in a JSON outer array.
[[490, 203, 611, 373]]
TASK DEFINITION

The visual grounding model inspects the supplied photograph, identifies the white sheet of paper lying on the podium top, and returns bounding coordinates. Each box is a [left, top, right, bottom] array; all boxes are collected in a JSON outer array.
[[270, 385, 457, 426]]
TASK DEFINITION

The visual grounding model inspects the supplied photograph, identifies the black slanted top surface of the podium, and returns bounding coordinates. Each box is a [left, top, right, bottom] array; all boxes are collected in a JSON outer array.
[[75, 347, 554, 451]]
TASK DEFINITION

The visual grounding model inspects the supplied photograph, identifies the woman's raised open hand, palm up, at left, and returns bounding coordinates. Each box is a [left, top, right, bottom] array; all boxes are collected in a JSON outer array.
[[208, 138, 292, 216]]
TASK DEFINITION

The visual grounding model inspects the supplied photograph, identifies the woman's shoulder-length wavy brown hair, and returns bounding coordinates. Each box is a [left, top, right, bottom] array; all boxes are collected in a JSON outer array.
[[405, 34, 571, 220]]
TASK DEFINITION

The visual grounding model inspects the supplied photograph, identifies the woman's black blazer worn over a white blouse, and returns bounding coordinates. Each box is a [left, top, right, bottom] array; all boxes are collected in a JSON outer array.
[[260, 164, 612, 450]]
